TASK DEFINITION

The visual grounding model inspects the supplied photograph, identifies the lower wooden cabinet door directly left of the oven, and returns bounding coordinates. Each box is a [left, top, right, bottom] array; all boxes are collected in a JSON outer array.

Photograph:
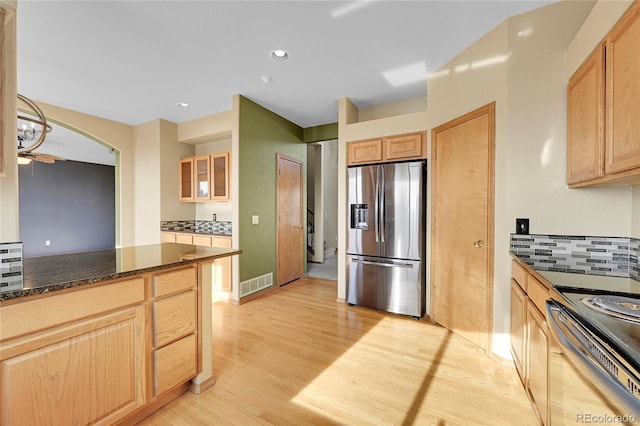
[[527, 303, 549, 425]]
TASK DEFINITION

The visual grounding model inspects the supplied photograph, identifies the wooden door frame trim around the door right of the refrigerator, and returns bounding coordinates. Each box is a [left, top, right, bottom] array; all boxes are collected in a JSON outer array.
[[430, 102, 495, 355]]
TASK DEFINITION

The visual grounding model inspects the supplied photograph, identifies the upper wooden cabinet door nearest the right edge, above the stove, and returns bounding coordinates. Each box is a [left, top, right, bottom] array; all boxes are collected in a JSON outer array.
[[606, 2, 640, 173]]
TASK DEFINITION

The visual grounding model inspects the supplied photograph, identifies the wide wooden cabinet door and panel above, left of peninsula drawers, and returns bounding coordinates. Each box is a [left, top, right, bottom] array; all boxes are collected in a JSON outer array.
[[0, 278, 147, 425]]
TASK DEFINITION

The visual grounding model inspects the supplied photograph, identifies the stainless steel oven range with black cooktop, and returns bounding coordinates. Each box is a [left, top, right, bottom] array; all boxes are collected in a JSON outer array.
[[546, 283, 640, 425]]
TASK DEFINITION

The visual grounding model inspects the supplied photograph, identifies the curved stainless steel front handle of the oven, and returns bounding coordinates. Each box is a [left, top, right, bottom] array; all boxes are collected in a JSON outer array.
[[546, 300, 640, 418]]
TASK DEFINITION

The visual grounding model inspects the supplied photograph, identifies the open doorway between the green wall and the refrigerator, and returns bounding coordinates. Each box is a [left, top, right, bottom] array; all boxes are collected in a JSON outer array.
[[307, 139, 338, 281]]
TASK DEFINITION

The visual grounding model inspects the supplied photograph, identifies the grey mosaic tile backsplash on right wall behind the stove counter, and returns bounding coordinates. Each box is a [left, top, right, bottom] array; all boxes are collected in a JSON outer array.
[[510, 234, 640, 280]]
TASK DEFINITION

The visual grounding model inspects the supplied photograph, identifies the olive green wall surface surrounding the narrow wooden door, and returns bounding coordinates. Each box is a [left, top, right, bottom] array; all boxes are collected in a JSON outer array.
[[237, 96, 307, 283]]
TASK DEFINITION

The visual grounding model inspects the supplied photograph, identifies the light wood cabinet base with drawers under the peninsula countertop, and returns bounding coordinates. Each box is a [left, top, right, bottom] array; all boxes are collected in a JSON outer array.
[[0, 265, 201, 425]]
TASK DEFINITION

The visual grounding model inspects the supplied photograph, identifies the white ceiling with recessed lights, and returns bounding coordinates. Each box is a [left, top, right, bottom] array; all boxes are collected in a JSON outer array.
[[17, 0, 553, 164]]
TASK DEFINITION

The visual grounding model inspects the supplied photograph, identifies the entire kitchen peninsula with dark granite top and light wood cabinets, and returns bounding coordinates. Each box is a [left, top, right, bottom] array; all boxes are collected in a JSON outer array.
[[0, 243, 242, 425]]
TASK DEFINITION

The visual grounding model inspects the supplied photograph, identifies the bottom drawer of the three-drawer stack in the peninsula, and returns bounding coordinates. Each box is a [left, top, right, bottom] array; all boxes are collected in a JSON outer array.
[[153, 334, 198, 396]]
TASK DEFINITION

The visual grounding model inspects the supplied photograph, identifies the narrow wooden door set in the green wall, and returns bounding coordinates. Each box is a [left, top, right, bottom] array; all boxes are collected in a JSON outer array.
[[276, 154, 304, 286]]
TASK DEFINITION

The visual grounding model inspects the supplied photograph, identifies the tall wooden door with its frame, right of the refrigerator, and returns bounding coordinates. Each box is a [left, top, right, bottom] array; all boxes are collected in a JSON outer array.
[[431, 103, 495, 353]]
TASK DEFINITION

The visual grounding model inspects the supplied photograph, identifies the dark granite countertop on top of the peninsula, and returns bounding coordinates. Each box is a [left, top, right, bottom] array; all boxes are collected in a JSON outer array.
[[0, 243, 242, 303]]
